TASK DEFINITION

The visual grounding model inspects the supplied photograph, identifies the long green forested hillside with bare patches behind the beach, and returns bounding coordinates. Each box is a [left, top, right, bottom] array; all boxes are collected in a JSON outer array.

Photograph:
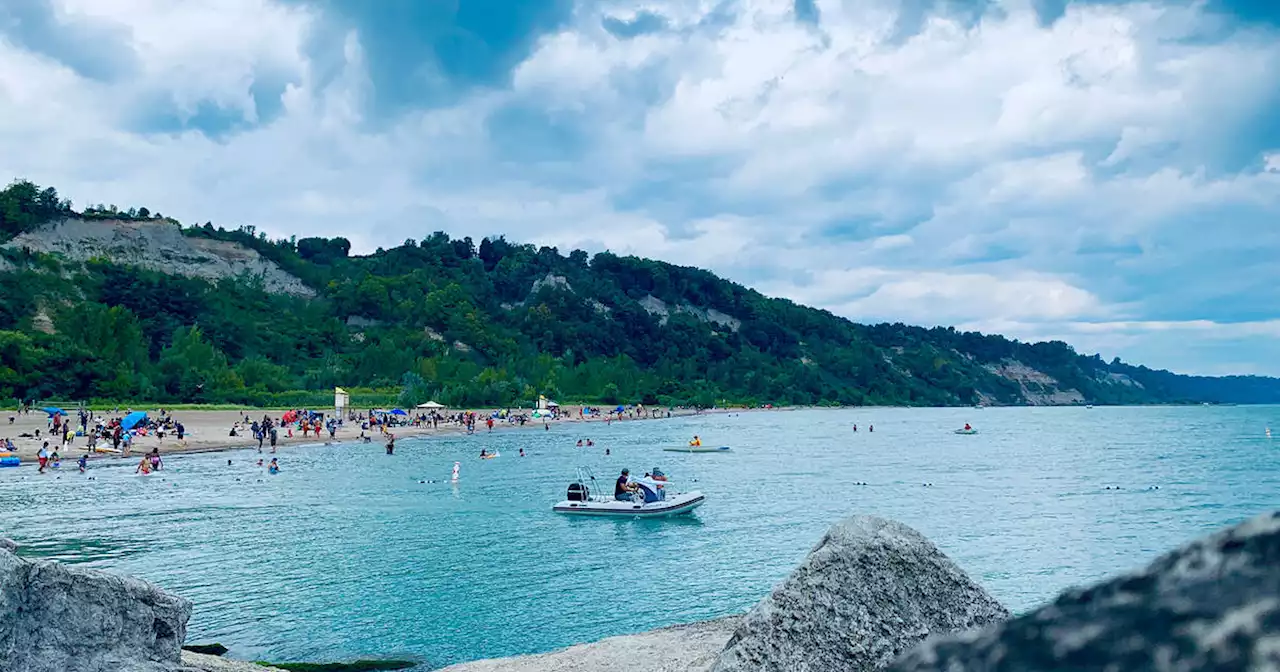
[[0, 182, 1280, 407]]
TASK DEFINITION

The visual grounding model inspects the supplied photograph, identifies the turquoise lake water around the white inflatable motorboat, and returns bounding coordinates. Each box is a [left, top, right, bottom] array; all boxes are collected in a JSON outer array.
[[0, 406, 1280, 667]]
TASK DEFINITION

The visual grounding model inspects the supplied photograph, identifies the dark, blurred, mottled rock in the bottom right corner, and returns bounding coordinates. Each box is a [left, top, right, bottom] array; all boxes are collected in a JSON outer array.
[[891, 512, 1280, 672]]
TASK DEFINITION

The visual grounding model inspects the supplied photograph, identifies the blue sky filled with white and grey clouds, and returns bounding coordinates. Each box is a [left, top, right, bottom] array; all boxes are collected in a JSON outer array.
[[0, 0, 1280, 375]]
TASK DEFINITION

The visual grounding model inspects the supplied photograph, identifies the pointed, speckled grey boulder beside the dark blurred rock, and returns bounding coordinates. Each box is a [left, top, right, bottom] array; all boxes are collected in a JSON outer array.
[[713, 516, 1009, 672]]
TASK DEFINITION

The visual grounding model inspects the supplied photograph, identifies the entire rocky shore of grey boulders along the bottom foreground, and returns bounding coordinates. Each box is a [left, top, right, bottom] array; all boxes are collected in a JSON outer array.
[[0, 511, 1280, 672]]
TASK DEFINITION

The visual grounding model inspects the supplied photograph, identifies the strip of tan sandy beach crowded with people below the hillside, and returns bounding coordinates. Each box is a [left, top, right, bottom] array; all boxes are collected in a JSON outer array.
[[0, 406, 744, 462]]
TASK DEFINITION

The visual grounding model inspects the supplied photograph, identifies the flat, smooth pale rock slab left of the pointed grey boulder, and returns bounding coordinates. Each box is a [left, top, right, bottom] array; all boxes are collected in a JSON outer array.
[[440, 617, 740, 672]]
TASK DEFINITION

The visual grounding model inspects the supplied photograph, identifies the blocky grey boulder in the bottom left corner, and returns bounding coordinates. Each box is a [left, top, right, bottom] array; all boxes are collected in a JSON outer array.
[[0, 550, 191, 672]]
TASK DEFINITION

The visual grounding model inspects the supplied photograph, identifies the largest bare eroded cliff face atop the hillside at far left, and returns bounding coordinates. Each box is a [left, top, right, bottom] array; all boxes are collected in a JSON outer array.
[[0, 219, 315, 297]]
